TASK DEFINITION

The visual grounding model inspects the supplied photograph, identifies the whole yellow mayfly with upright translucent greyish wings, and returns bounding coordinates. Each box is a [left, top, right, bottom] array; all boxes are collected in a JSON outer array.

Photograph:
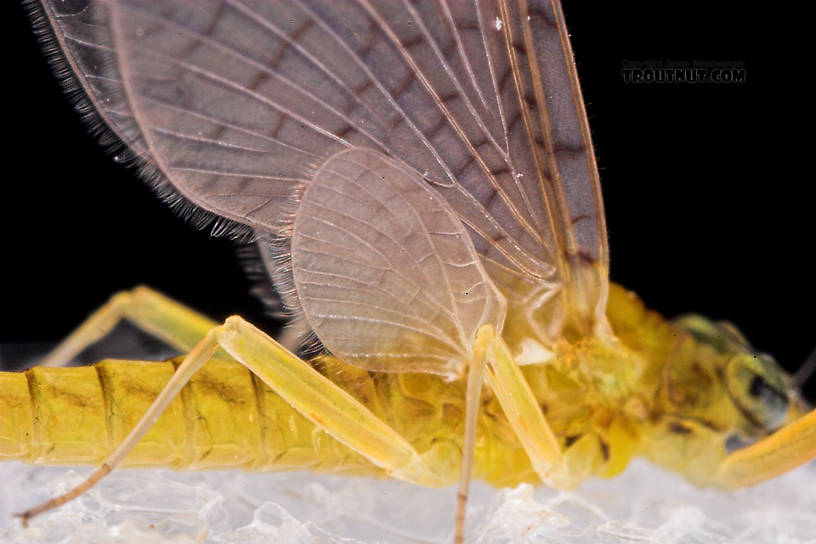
[[3, 1, 816, 538]]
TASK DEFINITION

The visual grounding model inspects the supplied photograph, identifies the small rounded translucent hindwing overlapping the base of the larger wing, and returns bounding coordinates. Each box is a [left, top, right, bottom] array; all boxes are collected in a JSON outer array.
[[292, 148, 505, 377]]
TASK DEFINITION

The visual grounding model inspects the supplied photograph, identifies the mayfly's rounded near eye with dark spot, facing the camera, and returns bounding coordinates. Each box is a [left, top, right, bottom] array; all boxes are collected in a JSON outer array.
[[726, 354, 789, 431]]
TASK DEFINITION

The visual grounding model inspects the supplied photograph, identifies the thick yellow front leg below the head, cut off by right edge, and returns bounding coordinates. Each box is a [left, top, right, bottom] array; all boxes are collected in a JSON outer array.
[[714, 410, 816, 488]]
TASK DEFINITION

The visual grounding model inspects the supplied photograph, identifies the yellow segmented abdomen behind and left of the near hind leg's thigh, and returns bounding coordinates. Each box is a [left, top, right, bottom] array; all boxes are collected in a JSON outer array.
[[0, 360, 379, 474]]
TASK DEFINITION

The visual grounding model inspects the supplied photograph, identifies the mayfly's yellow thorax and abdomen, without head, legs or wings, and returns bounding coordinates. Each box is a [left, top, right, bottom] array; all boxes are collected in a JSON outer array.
[[0, 286, 799, 486]]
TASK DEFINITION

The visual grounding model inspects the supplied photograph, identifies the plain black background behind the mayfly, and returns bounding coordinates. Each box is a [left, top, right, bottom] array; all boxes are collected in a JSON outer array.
[[0, 2, 816, 398]]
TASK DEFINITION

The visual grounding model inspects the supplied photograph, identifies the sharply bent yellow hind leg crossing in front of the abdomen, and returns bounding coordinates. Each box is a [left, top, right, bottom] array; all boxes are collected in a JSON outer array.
[[18, 316, 444, 524]]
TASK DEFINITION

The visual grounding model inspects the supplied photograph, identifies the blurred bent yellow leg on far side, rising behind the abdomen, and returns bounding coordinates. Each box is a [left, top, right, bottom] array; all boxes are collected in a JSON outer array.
[[40, 287, 220, 366]]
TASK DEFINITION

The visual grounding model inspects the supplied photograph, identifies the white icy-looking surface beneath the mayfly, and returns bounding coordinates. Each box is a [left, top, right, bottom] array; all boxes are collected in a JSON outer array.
[[0, 461, 816, 544]]
